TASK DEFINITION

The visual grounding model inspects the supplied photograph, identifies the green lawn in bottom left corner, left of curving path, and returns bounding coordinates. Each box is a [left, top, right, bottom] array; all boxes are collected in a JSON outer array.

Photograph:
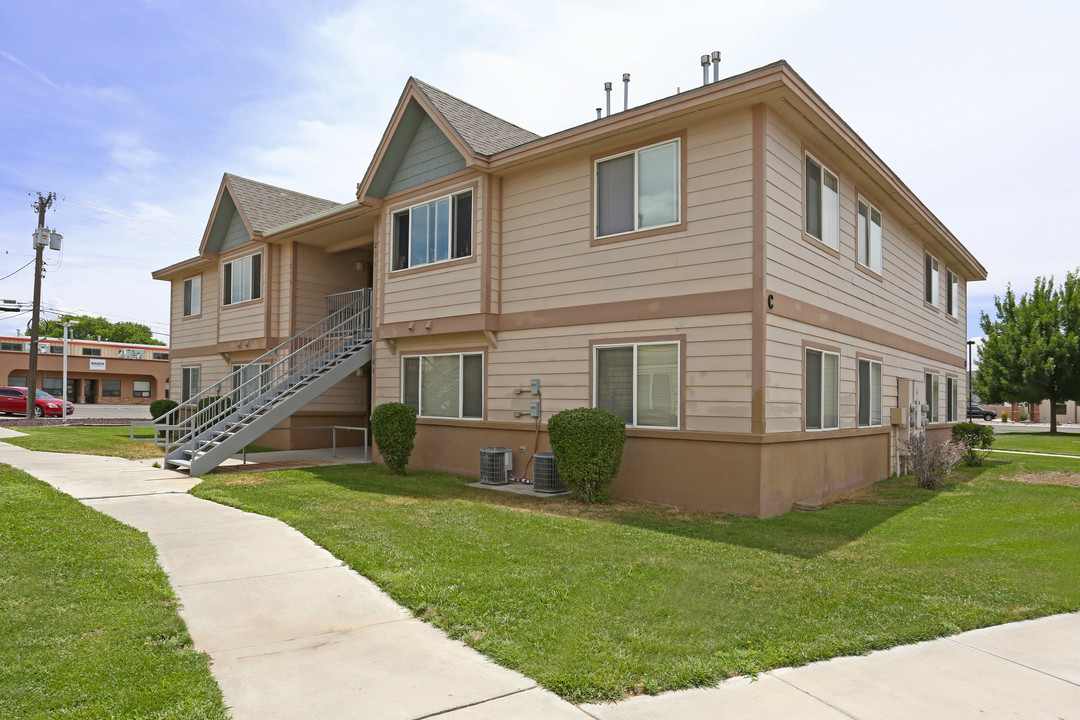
[[0, 465, 226, 720]]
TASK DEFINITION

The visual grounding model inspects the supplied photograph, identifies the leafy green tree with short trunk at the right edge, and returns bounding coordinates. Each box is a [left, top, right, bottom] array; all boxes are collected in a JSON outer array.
[[973, 271, 1080, 433]]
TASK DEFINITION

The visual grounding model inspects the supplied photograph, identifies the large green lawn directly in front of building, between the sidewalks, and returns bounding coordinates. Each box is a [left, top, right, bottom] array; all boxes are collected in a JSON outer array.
[[192, 456, 1080, 702]]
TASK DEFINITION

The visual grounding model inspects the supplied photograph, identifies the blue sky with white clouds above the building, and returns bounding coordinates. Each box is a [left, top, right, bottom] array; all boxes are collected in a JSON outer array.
[[0, 0, 1080, 341]]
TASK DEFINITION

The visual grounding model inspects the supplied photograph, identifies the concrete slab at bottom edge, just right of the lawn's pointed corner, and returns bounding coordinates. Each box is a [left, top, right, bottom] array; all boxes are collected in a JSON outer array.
[[581, 675, 850, 720]]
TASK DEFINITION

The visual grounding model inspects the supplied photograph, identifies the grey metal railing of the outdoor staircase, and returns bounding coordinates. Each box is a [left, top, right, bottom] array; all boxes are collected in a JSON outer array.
[[154, 287, 372, 462]]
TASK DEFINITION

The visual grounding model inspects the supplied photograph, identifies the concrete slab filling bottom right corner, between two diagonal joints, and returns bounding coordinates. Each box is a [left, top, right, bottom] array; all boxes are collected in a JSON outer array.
[[771, 639, 1080, 720]]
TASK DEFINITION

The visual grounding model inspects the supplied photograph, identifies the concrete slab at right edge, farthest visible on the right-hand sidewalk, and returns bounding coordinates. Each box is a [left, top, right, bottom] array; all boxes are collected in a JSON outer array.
[[951, 614, 1080, 685]]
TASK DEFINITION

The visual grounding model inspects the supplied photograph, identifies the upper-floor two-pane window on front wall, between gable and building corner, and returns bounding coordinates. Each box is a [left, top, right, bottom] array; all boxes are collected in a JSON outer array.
[[595, 138, 681, 237]]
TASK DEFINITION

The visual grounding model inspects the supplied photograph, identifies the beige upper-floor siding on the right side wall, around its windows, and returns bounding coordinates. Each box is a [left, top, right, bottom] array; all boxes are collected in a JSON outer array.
[[766, 114, 966, 362]]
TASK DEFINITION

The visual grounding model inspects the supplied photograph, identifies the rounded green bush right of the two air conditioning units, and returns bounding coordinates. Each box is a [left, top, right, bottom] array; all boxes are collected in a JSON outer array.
[[548, 408, 626, 503]]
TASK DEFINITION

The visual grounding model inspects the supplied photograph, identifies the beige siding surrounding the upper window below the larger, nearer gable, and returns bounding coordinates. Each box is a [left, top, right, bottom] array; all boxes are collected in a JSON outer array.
[[377, 178, 490, 323]]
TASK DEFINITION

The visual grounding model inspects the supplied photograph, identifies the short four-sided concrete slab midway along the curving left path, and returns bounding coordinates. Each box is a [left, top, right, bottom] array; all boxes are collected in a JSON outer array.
[[176, 567, 411, 653]]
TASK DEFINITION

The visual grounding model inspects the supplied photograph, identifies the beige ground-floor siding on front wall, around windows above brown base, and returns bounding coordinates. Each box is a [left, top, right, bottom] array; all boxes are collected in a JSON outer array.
[[375, 313, 751, 433]]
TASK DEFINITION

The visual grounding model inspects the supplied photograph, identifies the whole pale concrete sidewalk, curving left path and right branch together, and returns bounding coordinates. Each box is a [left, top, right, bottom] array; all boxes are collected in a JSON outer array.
[[0, 429, 1080, 720]]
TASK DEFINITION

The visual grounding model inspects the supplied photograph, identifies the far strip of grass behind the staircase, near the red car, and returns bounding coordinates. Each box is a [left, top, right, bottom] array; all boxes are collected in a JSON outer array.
[[2, 425, 274, 460]]
